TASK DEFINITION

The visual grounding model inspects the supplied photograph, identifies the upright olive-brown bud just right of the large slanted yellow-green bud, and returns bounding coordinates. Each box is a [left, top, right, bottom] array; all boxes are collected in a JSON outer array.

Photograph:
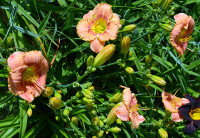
[[121, 36, 131, 59]]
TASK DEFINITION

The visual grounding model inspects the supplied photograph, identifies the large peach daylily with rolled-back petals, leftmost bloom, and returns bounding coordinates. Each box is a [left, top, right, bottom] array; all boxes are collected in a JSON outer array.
[[8, 51, 49, 102]]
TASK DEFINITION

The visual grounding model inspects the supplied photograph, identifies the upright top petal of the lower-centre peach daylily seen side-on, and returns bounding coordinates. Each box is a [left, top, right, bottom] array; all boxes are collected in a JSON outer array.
[[123, 88, 132, 109]]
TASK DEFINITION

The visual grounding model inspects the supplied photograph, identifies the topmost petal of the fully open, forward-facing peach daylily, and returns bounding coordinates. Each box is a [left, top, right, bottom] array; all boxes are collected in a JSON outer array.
[[93, 3, 113, 21]]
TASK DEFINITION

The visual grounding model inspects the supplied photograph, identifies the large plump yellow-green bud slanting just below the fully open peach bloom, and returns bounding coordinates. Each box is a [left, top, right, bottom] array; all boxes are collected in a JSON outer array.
[[93, 44, 116, 67]]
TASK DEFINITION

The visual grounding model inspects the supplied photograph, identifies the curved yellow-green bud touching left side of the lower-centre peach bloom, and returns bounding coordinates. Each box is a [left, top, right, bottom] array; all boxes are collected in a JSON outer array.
[[107, 103, 121, 125]]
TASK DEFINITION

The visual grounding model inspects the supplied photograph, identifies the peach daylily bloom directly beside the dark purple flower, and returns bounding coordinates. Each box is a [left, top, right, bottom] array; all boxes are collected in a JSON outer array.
[[162, 90, 189, 122]]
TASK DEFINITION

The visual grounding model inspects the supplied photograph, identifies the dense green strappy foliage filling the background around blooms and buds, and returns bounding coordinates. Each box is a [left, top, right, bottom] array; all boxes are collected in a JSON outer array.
[[0, 0, 200, 138]]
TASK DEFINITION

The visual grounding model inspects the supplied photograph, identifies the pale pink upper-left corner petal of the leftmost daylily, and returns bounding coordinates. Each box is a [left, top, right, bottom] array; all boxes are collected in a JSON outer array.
[[8, 51, 24, 70]]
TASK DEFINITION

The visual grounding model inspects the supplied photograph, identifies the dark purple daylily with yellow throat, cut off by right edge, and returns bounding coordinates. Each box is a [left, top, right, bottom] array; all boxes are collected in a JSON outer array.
[[178, 95, 200, 135]]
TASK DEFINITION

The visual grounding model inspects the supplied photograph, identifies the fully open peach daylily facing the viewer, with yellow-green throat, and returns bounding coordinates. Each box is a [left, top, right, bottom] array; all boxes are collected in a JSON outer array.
[[76, 3, 121, 53]]
